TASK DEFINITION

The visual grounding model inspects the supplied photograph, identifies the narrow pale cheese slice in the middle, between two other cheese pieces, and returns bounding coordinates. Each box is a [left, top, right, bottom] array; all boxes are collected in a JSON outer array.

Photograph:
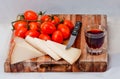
[[25, 36, 61, 61]]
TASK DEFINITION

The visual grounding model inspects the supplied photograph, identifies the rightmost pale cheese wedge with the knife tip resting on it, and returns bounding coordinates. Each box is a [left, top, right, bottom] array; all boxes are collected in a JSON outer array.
[[46, 40, 81, 64]]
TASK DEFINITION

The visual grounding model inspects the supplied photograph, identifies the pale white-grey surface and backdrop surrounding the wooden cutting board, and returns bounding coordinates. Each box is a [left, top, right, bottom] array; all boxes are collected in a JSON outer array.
[[0, 0, 120, 79]]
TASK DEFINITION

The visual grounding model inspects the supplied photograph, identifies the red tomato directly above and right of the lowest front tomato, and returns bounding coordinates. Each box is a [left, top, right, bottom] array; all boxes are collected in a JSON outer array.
[[58, 24, 70, 39]]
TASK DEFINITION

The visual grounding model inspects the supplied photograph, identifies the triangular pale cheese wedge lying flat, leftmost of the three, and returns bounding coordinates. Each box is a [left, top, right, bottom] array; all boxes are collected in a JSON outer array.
[[11, 37, 44, 64]]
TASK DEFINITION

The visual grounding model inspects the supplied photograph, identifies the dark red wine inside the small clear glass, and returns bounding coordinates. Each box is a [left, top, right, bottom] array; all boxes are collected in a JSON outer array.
[[85, 29, 105, 49]]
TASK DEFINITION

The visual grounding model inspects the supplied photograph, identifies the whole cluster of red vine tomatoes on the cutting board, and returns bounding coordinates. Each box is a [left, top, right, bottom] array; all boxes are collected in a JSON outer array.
[[12, 10, 74, 43]]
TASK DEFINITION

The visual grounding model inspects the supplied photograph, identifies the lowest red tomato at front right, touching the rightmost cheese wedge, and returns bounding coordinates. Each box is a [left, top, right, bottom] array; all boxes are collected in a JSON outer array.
[[52, 30, 63, 43]]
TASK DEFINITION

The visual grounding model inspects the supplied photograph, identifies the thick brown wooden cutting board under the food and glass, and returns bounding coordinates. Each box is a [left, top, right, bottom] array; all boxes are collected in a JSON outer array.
[[4, 14, 108, 72]]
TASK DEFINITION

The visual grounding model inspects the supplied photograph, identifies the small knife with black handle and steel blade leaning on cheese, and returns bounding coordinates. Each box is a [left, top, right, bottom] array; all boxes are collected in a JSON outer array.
[[66, 21, 82, 49]]
